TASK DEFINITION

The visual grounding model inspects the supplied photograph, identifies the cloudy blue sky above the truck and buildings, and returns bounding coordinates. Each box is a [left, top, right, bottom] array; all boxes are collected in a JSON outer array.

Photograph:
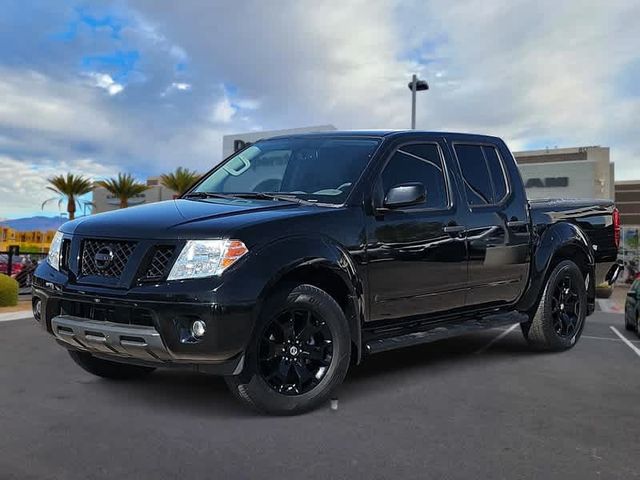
[[0, 0, 640, 218]]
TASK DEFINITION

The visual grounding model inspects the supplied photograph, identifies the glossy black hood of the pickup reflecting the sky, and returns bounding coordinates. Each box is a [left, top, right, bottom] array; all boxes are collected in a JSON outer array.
[[61, 199, 299, 239]]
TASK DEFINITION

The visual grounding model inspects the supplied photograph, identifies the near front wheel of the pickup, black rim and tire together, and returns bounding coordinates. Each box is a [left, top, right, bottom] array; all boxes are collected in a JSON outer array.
[[225, 284, 351, 415]]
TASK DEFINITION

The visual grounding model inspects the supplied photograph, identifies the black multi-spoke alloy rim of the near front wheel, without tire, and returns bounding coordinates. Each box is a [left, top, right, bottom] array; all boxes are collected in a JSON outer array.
[[258, 309, 333, 395]]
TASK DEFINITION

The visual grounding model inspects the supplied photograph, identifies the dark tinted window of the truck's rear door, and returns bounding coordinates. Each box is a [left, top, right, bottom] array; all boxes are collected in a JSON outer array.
[[455, 145, 508, 206]]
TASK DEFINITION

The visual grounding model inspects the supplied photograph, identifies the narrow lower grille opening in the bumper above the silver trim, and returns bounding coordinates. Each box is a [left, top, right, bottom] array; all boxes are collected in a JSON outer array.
[[60, 300, 154, 327]]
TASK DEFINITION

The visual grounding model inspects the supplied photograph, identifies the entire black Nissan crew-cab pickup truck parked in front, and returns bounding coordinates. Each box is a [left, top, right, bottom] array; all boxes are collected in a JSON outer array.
[[33, 131, 620, 414]]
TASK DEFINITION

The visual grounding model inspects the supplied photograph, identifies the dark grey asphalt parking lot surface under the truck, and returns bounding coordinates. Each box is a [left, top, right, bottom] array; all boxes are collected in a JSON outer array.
[[0, 313, 640, 480]]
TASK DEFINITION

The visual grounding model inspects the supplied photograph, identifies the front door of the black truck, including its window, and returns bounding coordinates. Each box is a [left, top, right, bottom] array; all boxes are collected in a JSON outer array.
[[367, 139, 467, 321]]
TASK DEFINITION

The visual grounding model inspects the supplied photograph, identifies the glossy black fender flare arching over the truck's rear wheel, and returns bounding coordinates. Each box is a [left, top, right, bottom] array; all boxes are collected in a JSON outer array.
[[516, 222, 595, 312]]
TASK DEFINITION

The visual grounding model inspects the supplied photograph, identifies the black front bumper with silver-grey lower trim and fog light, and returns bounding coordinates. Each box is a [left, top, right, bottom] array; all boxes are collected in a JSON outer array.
[[33, 284, 253, 375]]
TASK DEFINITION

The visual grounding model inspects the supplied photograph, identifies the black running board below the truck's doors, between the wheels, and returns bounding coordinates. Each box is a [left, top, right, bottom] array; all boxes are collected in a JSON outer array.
[[365, 312, 529, 354]]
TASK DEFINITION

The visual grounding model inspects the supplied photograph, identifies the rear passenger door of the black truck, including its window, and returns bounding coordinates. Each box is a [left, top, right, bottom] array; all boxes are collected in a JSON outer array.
[[452, 142, 530, 307]]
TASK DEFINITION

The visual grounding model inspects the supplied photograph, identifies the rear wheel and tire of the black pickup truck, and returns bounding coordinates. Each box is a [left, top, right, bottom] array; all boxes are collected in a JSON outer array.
[[522, 260, 587, 352]]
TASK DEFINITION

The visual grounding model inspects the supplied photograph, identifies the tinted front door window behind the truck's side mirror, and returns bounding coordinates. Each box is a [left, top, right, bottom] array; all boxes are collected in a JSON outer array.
[[381, 143, 449, 209]]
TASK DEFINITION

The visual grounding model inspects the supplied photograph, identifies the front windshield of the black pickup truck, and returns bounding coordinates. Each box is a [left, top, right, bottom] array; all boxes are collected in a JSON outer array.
[[191, 137, 380, 204]]
